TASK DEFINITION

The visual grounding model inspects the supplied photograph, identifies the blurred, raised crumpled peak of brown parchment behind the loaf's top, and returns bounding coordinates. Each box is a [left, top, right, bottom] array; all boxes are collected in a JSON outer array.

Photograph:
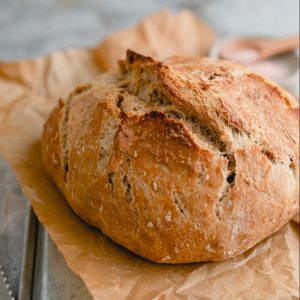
[[96, 10, 215, 70]]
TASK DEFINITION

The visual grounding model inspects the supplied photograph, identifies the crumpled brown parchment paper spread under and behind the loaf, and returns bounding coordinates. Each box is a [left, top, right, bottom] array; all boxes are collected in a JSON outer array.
[[0, 12, 299, 300]]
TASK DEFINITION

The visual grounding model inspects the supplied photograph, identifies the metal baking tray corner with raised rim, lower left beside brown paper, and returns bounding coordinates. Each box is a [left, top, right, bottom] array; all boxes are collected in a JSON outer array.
[[18, 208, 92, 300]]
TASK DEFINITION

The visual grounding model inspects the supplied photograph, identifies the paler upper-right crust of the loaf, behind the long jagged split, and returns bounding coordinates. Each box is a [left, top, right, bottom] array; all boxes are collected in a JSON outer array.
[[123, 52, 299, 162]]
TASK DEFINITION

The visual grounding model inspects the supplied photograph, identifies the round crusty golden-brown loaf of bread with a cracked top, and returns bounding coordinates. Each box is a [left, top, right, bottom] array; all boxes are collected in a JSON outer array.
[[42, 51, 299, 263]]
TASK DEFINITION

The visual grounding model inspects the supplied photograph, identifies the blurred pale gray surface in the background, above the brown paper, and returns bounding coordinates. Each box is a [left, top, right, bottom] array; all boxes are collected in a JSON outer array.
[[0, 0, 299, 60]]
